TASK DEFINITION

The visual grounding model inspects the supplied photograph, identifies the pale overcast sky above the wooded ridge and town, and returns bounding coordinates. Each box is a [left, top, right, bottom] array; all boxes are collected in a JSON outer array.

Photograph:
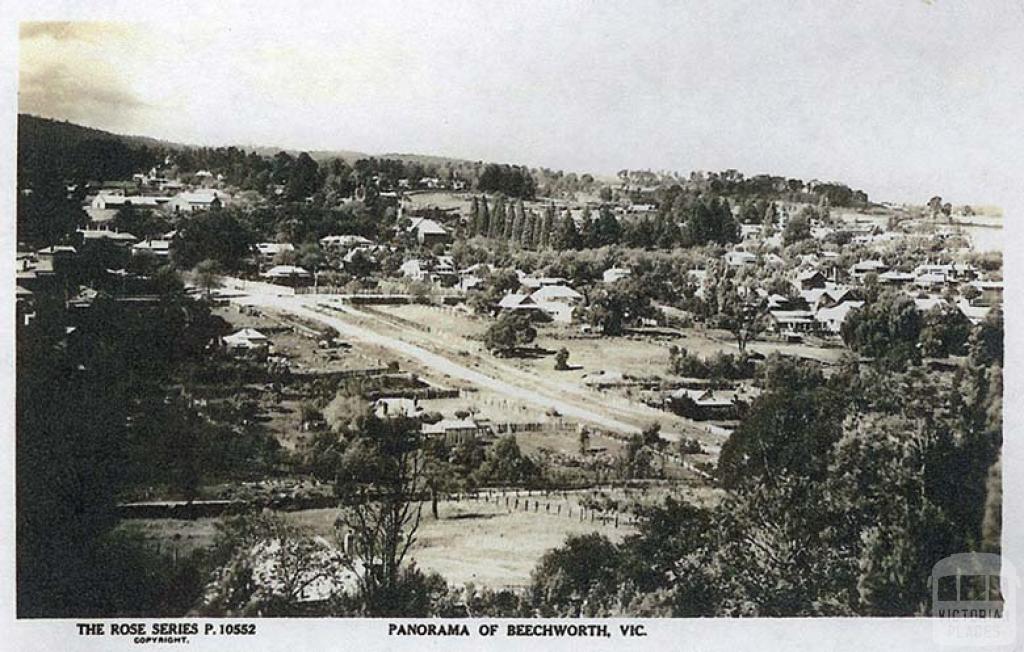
[[18, 0, 1024, 204]]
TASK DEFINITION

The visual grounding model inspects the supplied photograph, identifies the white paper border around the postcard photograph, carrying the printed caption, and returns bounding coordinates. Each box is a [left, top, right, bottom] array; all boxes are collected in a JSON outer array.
[[0, 0, 1024, 652]]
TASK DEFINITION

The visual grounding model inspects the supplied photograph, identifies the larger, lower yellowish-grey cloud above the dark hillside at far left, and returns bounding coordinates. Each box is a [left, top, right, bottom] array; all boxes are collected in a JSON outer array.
[[18, 63, 152, 127]]
